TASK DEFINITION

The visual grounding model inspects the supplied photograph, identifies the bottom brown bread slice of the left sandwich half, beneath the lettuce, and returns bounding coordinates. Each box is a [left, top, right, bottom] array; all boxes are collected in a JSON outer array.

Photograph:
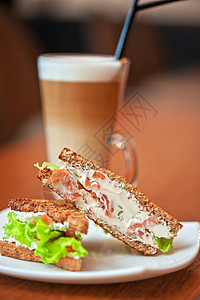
[[0, 241, 82, 271]]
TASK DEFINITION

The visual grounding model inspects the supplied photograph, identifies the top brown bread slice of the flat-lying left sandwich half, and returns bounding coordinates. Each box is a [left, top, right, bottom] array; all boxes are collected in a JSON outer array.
[[8, 198, 88, 237]]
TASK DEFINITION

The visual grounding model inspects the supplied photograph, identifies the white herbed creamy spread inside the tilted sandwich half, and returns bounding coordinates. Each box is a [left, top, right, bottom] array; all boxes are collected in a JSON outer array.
[[53, 164, 171, 248]]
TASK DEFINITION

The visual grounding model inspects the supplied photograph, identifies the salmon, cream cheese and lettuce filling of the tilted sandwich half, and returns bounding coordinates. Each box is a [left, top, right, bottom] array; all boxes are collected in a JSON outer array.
[[37, 162, 173, 252]]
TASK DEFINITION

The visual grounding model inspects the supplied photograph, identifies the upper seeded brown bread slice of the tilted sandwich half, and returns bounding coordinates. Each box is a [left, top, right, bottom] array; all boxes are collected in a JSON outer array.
[[59, 148, 182, 236]]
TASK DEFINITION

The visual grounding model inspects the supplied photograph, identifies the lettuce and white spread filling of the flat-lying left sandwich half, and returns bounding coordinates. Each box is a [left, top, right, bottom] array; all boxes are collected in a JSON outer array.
[[3, 211, 87, 264]]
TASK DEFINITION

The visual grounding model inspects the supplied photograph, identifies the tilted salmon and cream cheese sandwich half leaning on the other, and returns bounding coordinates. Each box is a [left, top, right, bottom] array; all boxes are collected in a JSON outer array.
[[36, 148, 182, 255]]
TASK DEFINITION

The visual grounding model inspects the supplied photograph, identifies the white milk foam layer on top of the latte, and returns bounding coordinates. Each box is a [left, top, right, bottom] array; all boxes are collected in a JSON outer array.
[[38, 55, 128, 82]]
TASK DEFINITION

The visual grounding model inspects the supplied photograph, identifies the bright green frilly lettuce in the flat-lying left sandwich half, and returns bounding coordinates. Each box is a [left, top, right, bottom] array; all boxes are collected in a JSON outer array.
[[3, 212, 88, 264]]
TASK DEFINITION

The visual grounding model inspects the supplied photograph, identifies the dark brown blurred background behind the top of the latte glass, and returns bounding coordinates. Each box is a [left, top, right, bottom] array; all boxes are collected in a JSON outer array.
[[0, 0, 200, 144]]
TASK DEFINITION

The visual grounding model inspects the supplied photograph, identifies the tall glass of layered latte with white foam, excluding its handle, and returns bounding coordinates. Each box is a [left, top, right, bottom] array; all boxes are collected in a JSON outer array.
[[38, 54, 138, 180]]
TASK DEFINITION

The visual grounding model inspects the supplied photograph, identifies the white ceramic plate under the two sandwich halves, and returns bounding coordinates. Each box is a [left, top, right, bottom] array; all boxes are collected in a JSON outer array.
[[0, 209, 199, 284]]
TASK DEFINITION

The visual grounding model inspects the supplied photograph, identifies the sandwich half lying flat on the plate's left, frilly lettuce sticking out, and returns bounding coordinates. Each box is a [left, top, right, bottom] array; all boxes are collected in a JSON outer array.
[[0, 198, 88, 271]]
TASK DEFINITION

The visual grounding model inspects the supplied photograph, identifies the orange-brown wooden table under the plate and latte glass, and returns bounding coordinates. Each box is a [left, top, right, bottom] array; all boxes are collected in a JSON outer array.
[[0, 73, 200, 300]]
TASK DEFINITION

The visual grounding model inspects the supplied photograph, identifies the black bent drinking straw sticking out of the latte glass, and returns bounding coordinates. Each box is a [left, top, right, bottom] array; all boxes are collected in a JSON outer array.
[[115, 0, 187, 59]]
